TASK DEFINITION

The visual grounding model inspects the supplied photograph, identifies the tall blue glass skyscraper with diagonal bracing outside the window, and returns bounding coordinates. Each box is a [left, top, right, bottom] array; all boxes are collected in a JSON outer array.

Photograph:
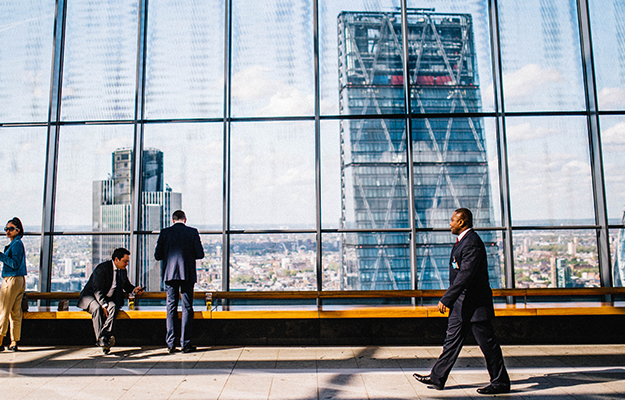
[[338, 12, 501, 289]]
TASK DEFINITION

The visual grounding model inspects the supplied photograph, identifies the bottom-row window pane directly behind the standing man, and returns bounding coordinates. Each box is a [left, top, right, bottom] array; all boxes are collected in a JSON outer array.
[[137, 234, 222, 292]]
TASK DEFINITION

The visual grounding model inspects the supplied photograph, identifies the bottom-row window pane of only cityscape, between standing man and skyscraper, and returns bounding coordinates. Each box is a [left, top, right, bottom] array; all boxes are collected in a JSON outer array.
[[230, 233, 317, 291]]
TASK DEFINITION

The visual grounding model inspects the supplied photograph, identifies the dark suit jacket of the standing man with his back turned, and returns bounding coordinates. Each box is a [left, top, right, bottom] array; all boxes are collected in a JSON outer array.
[[154, 222, 204, 283]]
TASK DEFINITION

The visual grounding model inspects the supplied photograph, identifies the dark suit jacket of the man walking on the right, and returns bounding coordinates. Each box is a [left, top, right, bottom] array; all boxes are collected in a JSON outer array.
[[441, 229, 495, 322]]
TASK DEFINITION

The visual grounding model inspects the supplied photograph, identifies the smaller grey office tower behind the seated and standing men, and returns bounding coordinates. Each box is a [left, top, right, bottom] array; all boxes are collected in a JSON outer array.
[[92, 149, 182, 291]]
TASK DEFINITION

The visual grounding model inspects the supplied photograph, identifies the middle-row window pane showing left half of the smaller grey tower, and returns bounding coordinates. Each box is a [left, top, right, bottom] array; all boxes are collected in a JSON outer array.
[[54, 125, 133, 238]]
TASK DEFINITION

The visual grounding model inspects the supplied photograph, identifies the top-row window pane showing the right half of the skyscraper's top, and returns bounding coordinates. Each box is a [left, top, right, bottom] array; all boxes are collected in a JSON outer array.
[[408, 0, 493, 113]]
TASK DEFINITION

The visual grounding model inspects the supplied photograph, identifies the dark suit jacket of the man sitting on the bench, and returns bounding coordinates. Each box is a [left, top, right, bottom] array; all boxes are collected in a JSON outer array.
[[78, 260, 135, 310]]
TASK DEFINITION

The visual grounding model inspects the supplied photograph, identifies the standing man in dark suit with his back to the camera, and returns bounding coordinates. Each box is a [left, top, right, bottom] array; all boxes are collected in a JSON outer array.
[[154, 210, 204, 353]]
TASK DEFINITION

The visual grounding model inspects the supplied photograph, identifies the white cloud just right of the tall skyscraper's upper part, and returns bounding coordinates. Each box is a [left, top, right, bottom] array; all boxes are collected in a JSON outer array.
[[503, 64, 562, 99]]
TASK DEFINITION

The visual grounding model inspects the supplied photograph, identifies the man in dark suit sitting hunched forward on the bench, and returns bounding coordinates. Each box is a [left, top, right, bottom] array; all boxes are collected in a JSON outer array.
[[78, 247, 143, 354]]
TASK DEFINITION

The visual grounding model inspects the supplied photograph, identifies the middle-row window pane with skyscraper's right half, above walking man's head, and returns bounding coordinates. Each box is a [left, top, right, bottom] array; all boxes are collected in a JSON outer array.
[[412, 118, 499, 228]]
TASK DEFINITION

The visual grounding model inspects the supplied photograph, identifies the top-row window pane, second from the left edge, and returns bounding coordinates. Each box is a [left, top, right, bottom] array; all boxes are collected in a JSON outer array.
[[61, 0, 139, 121]]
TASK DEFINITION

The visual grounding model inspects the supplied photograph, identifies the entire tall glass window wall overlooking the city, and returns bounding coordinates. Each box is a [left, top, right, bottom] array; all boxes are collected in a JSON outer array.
[[0, 0, 625, 291]]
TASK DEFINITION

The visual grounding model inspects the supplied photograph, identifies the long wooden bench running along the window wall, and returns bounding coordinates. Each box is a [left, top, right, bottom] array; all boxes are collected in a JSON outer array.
[[24, 288, 625, 319]]
